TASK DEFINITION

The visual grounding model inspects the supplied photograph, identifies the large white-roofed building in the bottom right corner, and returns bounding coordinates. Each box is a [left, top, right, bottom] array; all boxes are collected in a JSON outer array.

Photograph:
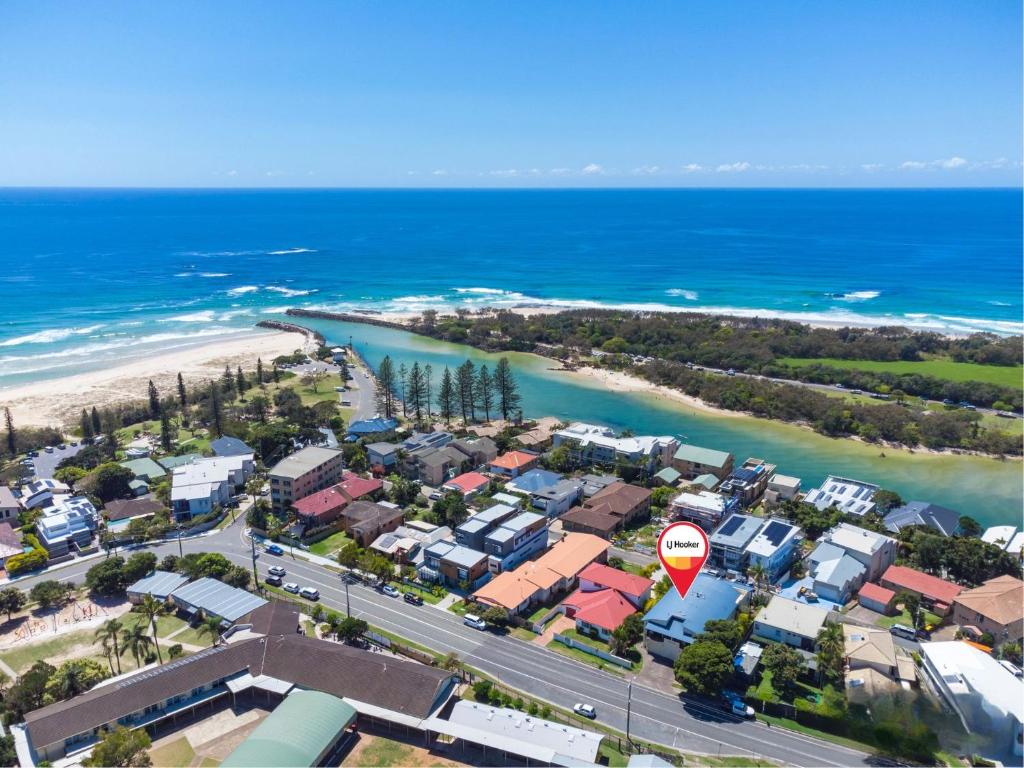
[[921, 641, 1024, 765]]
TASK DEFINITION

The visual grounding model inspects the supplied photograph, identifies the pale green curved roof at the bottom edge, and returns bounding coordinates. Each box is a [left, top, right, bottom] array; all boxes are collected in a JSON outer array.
[[220, 690, 355, 768]]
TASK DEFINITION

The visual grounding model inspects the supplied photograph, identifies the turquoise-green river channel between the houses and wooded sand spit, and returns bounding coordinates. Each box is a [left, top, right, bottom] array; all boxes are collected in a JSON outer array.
[[301, 318, 1024, 526]]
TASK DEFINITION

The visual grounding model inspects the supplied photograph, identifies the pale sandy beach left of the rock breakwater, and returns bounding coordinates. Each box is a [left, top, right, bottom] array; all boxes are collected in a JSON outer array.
[[0, 331, 307, 427]]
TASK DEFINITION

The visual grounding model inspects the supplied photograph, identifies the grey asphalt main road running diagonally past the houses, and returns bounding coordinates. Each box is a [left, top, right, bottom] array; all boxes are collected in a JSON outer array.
[[14, 519, 869, 768]]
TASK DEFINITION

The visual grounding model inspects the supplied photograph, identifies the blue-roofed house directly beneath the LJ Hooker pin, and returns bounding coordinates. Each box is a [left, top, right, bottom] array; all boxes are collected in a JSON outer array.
[[643, 572, 750, 663]]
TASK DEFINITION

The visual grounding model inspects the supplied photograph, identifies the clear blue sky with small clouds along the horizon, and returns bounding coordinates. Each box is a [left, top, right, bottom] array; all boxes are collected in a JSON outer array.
[[0, 0, 1022, 186]]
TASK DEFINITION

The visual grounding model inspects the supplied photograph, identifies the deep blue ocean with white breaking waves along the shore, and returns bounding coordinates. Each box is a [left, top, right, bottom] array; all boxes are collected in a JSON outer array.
[[0, 189, 1024, 388]]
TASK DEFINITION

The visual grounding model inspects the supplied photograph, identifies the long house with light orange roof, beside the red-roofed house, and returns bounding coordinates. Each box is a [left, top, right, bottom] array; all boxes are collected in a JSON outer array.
[[473, 534, 610, 613]]
